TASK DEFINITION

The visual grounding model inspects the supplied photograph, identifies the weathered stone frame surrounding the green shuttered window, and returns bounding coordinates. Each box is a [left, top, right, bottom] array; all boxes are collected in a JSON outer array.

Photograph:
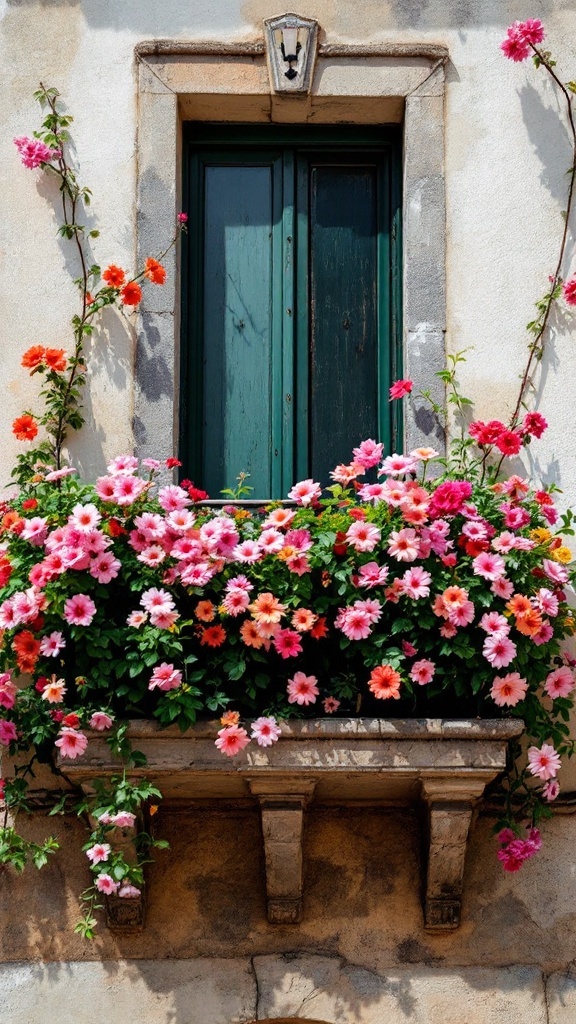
[[133, 40, 448, 459]]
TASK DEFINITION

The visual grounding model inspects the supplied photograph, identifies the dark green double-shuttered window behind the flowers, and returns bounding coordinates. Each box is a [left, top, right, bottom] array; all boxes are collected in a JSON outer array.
[[179, 124, 401, 498]]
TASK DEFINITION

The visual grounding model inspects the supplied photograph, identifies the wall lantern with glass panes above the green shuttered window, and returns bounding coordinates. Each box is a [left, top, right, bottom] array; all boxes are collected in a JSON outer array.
[[264, 14, 318, 95]]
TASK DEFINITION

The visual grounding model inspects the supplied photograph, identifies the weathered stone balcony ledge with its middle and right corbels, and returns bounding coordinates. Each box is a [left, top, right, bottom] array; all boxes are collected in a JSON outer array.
[[66, 719, 523, 931]]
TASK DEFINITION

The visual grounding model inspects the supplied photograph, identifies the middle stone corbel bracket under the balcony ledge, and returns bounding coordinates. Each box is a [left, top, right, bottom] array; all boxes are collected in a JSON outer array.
[[247, 775, 316, 925]]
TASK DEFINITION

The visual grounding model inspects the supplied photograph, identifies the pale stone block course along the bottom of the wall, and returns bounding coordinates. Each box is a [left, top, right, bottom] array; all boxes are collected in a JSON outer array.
[[0, 952, 557, 1024]]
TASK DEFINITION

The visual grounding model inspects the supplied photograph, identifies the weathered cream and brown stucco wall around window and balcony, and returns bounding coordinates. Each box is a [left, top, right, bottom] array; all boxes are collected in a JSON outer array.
[[0, 0, 576, 1024]]
